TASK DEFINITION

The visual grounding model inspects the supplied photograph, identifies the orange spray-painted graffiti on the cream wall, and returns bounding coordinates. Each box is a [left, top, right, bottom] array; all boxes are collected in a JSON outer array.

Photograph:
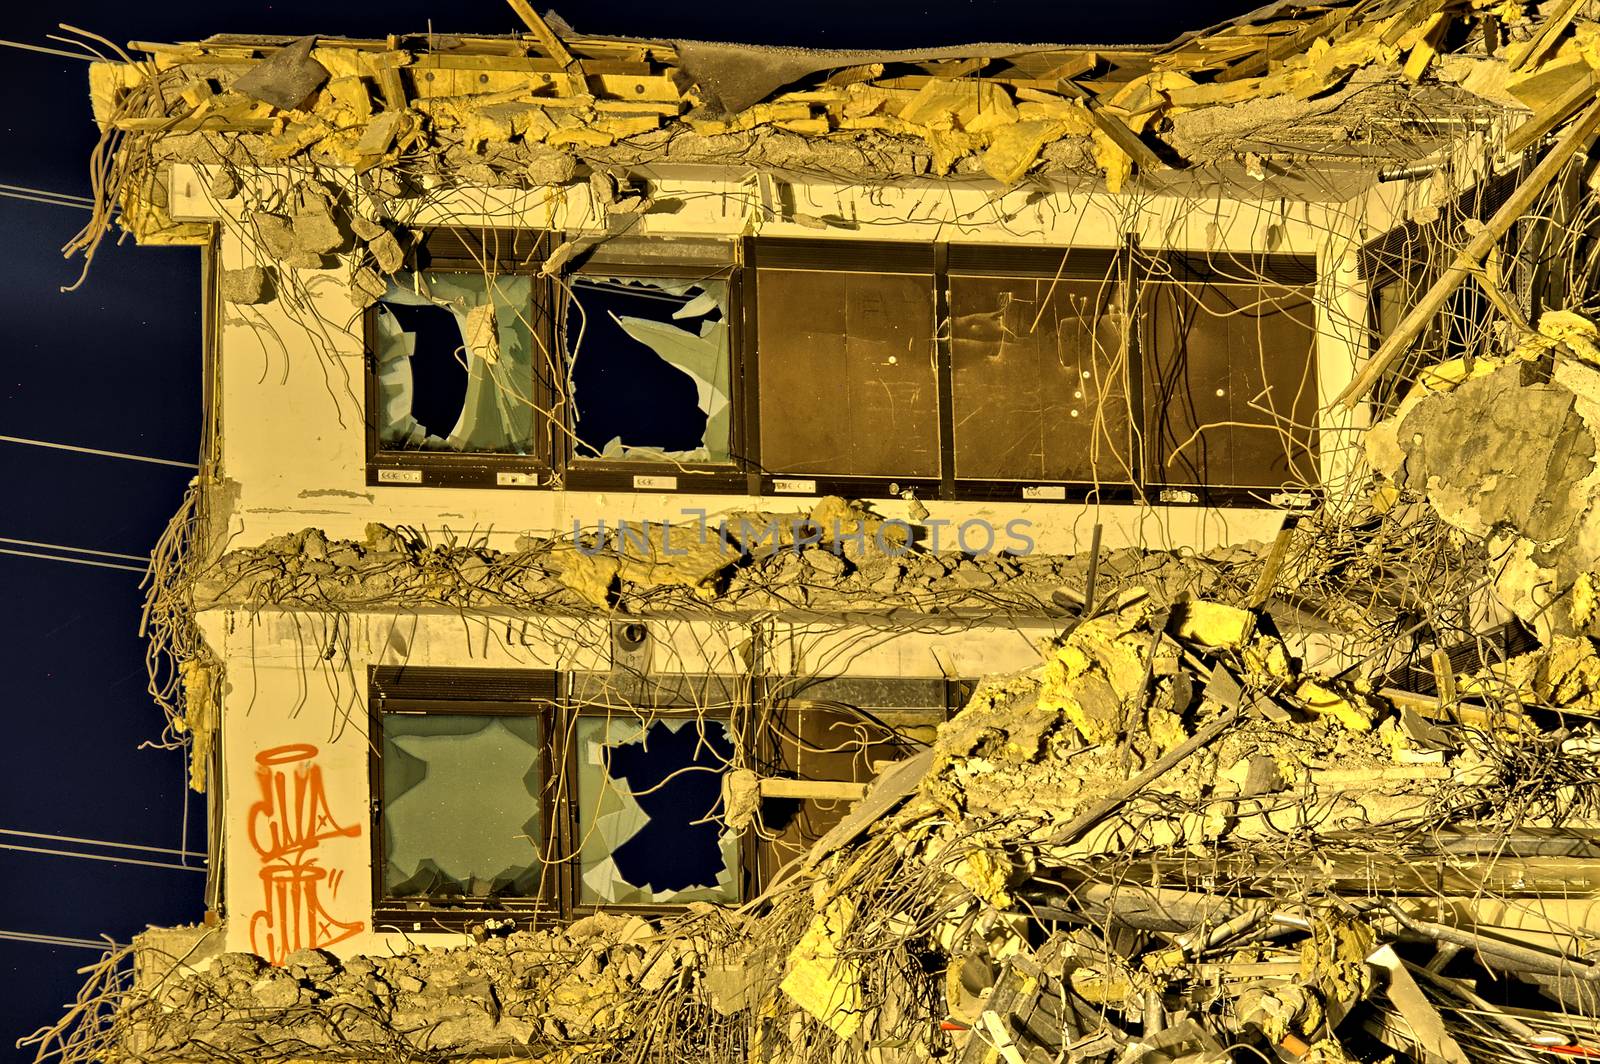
[[250, 742, 365, 965]]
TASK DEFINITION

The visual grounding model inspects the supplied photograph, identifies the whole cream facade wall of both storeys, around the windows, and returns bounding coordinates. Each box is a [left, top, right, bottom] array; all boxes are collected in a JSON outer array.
[[173, 161, 1401, 958]]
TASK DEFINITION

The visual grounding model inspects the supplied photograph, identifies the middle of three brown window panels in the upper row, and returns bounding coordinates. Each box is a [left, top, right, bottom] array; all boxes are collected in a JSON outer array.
[[949, 251, 1134, 483]]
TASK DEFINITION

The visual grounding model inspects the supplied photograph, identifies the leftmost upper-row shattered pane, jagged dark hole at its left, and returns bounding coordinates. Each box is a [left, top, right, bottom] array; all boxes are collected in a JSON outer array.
[[373, 270, 534, 454]]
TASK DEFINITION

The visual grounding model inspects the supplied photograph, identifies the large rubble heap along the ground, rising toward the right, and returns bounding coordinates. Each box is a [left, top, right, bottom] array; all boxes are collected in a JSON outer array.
[[59, 486, 1600, 1064]]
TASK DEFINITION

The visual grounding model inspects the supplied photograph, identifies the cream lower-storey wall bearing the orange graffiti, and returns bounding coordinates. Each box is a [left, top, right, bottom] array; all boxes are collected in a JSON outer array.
[[202, 610, 1054, 960]]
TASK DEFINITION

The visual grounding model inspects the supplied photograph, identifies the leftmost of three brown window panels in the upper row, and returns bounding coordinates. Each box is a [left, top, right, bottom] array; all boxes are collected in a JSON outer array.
[[757, 242, 939, 478]]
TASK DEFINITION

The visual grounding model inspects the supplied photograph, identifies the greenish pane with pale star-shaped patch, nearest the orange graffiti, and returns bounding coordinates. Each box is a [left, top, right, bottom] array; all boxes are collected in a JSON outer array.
[[381, 714, 544, 898]]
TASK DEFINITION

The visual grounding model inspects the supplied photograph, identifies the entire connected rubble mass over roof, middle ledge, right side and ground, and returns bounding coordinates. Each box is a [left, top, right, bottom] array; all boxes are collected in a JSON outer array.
[[43, 0, 1600, 1064]]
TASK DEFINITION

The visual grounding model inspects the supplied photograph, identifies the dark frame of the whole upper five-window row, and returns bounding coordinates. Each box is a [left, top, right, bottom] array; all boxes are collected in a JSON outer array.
[[363, 227, 1323, 509]]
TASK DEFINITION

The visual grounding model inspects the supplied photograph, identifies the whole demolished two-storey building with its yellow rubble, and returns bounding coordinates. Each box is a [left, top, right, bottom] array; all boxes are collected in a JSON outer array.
[[30, 0, 1600, 1064]]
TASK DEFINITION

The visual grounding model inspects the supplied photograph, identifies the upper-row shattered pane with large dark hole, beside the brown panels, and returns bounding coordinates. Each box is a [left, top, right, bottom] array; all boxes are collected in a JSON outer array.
[[566, 274, 733, 462]]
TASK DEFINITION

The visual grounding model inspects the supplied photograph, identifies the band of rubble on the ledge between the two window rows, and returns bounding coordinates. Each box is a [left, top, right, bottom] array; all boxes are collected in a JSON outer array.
[[194, 498, 1259, 614]]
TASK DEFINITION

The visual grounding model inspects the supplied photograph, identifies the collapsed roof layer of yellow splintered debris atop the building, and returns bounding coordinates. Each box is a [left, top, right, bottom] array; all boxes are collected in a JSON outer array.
[[72, 0, 1548, 252]]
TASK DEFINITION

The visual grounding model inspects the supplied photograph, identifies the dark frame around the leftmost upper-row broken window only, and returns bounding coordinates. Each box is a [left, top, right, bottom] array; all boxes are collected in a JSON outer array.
[[362, 226, 560, 488]]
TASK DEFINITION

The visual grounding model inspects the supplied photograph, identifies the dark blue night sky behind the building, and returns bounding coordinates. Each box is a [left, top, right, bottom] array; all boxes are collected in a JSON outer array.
[[0, 0, 1254, 1061]]
